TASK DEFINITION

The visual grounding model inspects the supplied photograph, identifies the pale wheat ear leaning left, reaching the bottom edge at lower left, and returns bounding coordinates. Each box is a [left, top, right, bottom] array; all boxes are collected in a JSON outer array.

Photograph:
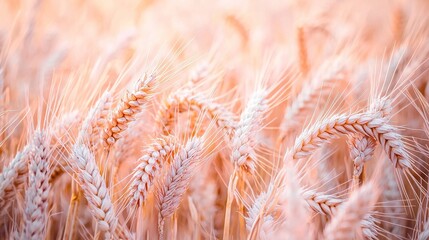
[[72, 144, 118, 239]]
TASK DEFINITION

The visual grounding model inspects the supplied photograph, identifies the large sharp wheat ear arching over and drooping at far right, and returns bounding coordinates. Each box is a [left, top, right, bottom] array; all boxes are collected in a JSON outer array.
[[290, 113, 411, 169]]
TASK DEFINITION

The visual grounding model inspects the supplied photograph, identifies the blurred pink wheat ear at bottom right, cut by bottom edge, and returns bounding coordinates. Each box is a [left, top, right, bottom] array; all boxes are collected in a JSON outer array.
[[324, 183, 378, 240]]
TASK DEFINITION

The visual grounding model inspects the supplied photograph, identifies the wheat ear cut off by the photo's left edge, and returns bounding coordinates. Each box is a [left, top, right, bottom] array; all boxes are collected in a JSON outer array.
[[0, 145, 31, 216]]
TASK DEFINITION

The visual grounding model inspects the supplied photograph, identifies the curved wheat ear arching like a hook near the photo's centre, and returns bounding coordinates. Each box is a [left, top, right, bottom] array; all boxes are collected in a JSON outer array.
[[157, 90, 235, 137]]
